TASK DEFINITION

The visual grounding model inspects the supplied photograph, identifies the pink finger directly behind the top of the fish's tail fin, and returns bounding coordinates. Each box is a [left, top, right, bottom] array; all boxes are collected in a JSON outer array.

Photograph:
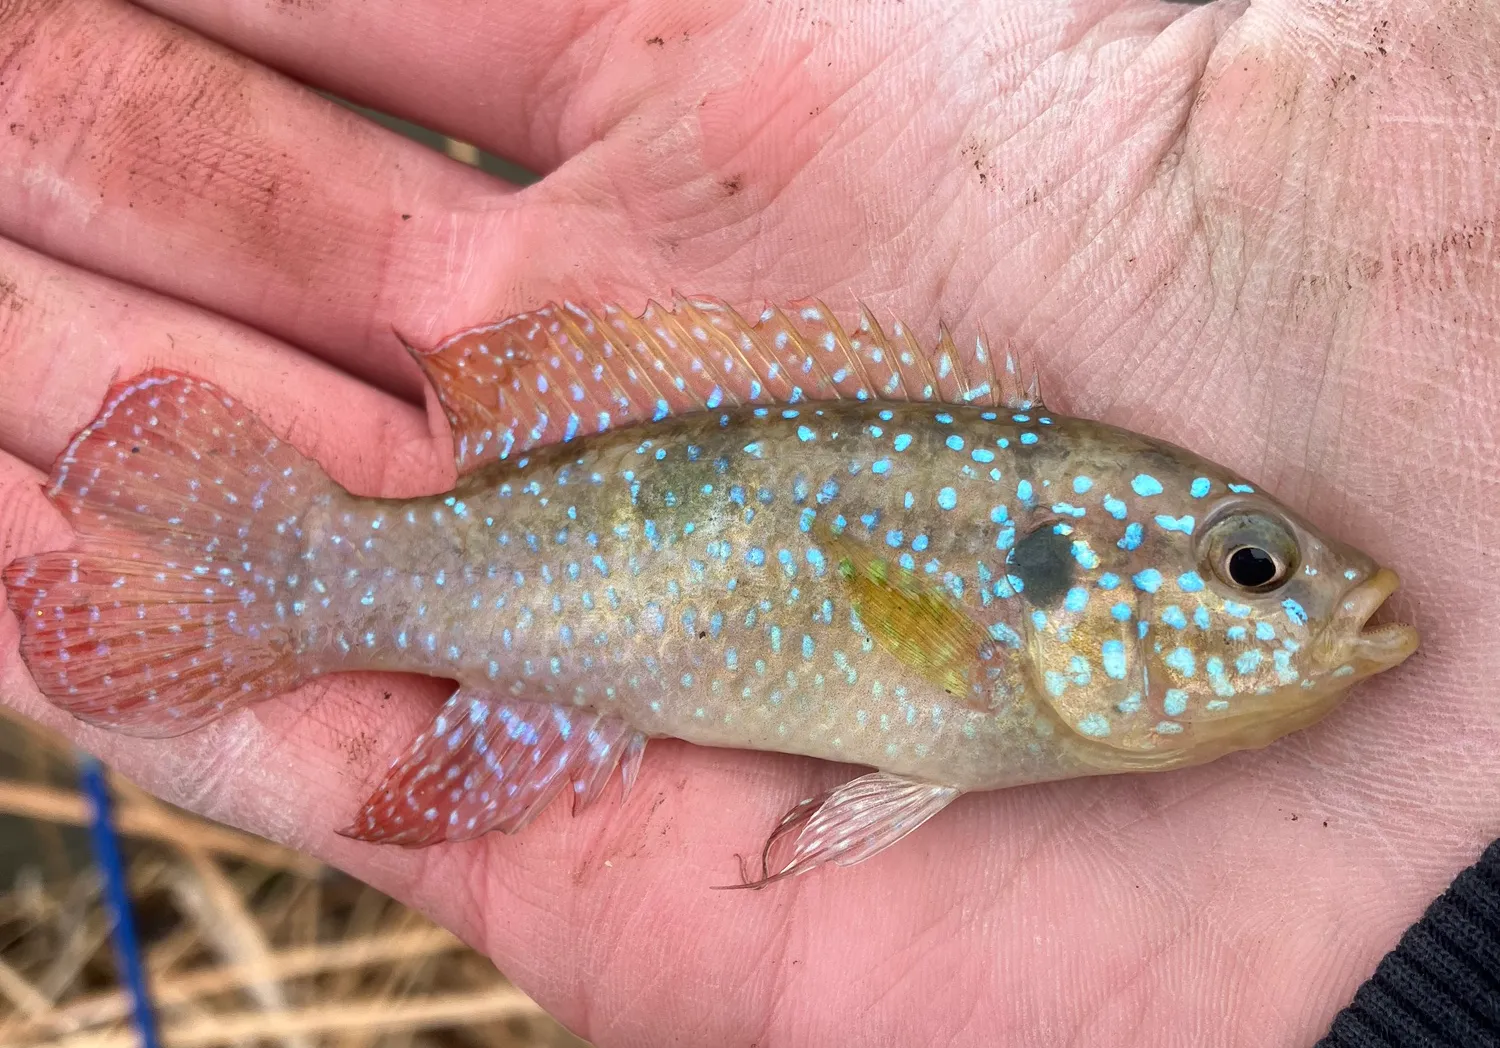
[[0, 233, 452, 493]]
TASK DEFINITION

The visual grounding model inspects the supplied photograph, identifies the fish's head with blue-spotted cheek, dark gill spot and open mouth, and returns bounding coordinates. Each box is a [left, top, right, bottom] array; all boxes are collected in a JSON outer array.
[[1010, 434, 1418, 769]]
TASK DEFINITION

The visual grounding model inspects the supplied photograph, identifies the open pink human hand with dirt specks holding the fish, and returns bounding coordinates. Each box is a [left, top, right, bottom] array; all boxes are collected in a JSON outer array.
[[0, 0, 1500, 1048]]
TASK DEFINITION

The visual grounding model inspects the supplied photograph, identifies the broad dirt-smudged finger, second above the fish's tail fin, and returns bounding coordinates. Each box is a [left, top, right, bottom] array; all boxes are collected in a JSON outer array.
[[0, 0, 528, 394]]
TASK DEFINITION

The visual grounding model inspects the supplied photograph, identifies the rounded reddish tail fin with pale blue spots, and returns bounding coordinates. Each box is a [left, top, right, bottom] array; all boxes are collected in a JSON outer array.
[[0, 372, 333, 738]]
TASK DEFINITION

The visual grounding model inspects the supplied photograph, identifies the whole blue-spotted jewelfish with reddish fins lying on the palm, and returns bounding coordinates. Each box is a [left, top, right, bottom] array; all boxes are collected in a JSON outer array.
[[3, 300, 1418, 885]]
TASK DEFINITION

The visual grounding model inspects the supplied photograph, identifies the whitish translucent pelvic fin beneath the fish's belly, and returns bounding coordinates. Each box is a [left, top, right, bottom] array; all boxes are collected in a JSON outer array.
[[720, 772, 960, 889]]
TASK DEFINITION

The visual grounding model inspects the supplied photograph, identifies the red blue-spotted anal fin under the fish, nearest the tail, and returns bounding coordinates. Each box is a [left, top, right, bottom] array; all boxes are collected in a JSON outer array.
[[339, 688, 647, 847]]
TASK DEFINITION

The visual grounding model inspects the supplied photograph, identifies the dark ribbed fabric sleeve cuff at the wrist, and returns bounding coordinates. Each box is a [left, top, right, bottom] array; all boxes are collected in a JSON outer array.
[[1317, 841, 1500, 1048]]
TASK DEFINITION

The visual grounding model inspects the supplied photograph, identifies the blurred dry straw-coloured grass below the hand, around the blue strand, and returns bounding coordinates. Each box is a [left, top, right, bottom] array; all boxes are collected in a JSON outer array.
[[0, 715, 587, 1048]]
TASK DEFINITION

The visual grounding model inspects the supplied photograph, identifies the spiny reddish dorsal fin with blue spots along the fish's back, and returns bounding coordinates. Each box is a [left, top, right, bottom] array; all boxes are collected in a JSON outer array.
[[407, 297, 1041, 474]]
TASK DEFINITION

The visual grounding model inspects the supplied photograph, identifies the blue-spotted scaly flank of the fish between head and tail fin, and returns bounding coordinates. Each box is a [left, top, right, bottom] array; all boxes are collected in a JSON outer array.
[[303, 403, 1065, 787]]
